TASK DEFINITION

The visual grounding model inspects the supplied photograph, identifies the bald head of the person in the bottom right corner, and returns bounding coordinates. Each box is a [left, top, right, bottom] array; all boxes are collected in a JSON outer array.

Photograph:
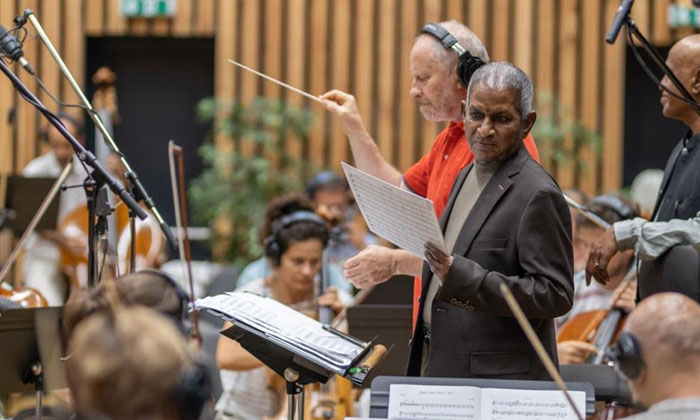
[[625, 293, 700, 373]]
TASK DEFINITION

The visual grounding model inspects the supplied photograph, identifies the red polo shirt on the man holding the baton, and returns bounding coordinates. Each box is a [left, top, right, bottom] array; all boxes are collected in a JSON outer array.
[[404, 122, 539, 324]]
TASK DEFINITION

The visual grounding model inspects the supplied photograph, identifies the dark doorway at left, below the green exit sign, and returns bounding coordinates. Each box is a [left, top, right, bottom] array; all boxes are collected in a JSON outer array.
[[86, 37, 214, 260]]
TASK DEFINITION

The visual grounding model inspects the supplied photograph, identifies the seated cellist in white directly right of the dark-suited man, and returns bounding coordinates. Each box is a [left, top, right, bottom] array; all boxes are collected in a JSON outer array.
[[555, 195, 640, 364]]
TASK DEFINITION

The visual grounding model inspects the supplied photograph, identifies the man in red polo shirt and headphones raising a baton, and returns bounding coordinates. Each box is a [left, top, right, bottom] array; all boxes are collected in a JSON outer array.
[[321, 20, 538, 322]]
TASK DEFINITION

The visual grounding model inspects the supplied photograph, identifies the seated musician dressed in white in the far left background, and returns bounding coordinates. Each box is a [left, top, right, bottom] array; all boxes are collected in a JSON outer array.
[[22, 113, 87, 306]]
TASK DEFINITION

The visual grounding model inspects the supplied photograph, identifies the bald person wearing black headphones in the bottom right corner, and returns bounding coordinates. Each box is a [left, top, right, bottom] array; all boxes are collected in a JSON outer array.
[[606, 292, 700, 420]]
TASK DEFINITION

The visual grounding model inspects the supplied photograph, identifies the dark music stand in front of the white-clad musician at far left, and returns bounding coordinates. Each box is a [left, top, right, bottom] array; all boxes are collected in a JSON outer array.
[[0, 175, 58, 237]]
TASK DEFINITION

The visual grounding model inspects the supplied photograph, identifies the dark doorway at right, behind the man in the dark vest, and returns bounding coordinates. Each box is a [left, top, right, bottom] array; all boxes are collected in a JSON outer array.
[[623, 47, 686, 185]]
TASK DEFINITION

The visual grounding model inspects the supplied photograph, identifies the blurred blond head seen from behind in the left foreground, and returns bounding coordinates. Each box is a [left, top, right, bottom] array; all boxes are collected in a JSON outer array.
[[66, 304, 211, 420]]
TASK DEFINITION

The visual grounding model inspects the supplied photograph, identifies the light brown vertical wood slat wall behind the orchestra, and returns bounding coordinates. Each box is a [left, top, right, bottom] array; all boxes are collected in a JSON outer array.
[[0, 0, 692, 197]]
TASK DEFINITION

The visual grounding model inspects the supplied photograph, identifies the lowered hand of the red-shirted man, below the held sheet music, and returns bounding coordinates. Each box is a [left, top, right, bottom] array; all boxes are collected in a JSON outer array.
[[343, 245, 398, 289]]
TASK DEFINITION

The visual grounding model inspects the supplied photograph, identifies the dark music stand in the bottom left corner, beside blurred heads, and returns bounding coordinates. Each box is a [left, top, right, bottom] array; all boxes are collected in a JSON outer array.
[[0, 307, 66, 419]]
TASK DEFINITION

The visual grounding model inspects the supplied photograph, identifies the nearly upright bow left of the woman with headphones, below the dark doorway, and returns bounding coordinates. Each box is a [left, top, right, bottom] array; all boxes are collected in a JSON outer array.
[[168, 140, 202, 346]]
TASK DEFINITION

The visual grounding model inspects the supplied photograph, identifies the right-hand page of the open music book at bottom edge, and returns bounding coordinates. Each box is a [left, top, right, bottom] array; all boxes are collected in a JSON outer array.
[[481, 388, 586, 420]]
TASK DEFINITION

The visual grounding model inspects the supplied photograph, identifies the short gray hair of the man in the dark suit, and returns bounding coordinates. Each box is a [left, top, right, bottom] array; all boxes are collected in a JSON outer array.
[[467, 61, 533, 118]]
